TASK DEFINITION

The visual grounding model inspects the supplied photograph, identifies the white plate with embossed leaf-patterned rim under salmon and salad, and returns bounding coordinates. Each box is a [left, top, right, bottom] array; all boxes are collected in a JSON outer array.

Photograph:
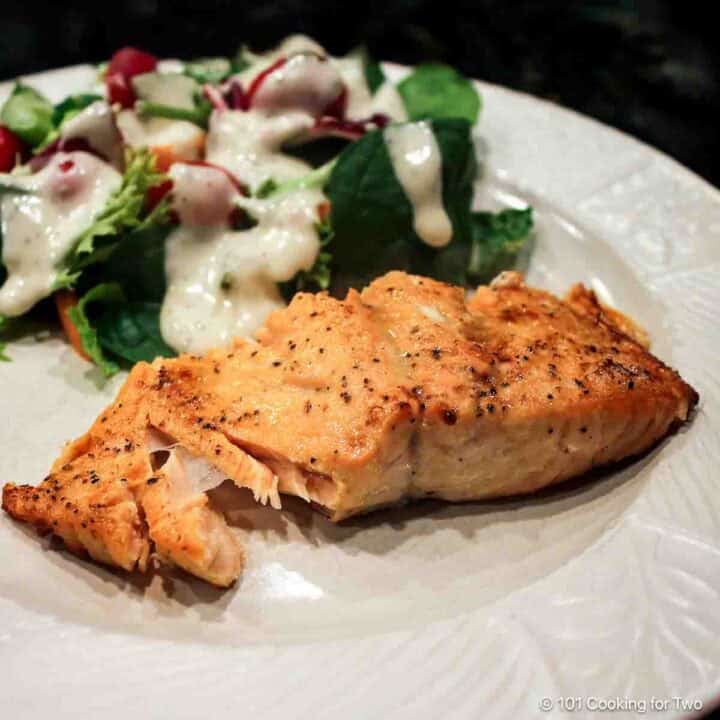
[[0, 67, 720, 720]]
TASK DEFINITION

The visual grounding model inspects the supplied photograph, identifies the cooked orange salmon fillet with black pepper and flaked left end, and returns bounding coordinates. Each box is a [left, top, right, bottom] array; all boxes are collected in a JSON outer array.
[[3, 272, 697, 586]]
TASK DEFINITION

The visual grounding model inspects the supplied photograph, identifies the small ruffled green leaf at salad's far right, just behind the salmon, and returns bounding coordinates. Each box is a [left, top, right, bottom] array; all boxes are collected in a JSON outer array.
[[467, 207, 533, 282]]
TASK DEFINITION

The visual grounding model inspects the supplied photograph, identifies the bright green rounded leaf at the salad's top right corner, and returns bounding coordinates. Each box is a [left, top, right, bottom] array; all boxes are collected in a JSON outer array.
[[397, 64, 481, 123]]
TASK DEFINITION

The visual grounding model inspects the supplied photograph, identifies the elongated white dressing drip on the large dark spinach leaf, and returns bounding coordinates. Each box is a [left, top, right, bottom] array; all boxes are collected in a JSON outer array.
[[384, 122, 452, 247]]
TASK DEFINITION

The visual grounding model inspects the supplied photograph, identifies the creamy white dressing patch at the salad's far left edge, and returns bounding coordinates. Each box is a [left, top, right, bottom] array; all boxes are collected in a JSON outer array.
[[0, 152, 122, 316]]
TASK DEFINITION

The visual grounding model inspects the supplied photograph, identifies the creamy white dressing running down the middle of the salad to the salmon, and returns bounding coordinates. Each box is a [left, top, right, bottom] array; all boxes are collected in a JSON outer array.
[[160, 38, 352, 352]]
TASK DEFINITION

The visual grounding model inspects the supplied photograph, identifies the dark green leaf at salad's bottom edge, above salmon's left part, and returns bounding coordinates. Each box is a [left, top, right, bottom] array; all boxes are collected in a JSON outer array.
[[97, 302, 176, 363]]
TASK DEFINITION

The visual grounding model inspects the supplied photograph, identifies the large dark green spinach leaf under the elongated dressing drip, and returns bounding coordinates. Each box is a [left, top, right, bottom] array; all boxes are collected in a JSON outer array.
[[325, 118, 477, 289]]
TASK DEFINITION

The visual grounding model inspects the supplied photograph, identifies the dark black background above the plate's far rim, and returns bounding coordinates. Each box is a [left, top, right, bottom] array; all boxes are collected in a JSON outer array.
[[0, 0, 720, 185]]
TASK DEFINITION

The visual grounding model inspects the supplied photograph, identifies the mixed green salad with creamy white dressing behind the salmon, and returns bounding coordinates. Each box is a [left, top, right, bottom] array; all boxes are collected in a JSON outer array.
[[0, 36, 532, 376]]
